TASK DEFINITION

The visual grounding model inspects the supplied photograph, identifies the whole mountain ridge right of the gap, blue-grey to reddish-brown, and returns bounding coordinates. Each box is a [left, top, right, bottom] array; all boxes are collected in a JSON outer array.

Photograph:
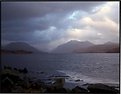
[[52, 40, 119, 53]]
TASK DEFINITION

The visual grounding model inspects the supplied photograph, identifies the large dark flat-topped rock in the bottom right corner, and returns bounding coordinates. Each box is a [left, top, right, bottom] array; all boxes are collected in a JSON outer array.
[[87, 83, 119, 94]]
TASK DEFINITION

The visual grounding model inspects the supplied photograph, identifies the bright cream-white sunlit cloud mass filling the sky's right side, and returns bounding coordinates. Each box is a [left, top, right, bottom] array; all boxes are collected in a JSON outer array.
[[68, 3, 119, 43]]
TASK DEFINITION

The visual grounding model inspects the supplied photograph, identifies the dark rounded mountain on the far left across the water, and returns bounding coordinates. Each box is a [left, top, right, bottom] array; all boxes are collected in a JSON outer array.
[[2, 42, 43, 53]]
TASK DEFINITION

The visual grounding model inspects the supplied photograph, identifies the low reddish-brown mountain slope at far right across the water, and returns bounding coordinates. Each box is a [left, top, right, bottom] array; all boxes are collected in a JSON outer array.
[[74, 42, 119, 53]]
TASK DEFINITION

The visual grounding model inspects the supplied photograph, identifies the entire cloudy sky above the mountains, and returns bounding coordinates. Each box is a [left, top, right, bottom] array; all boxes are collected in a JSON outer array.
[[1, 1, 119, 51]]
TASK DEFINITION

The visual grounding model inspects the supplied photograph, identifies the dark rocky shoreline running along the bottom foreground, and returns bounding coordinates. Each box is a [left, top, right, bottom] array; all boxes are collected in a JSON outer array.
[[1, 66, 119, 94]]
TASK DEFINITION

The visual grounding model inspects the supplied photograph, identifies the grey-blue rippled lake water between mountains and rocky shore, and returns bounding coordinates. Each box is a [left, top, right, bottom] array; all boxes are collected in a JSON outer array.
[[2, 53, 119, 83]]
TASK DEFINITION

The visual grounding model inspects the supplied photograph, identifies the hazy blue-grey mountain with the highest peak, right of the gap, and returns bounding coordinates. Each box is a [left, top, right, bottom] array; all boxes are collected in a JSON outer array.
[[52, 40, 94, 53]]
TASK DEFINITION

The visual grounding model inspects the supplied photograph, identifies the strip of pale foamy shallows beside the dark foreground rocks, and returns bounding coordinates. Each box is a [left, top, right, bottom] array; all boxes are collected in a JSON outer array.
[[27, 70, 119, 86]]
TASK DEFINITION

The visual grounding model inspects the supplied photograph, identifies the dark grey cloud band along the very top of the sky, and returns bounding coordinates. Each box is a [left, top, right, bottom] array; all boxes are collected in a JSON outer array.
[[1, 2, 103, 20]]
